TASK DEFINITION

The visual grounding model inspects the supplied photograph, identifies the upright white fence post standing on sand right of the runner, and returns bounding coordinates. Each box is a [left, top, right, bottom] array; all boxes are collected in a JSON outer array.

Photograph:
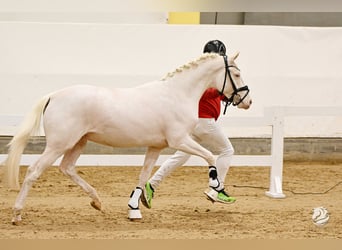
[[266, 107, 285, 198]]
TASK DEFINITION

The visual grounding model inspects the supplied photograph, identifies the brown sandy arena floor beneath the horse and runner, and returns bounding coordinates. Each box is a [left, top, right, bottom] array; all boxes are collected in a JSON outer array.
[[0, 163, 342, 239]]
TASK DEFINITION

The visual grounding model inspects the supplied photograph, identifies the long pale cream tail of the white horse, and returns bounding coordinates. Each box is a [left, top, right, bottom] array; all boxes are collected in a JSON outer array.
[[3, 96, 49, 189]]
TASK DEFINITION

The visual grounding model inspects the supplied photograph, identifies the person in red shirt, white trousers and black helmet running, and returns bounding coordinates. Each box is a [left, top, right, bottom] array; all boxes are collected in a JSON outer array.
[[141, 40, 236, 208]]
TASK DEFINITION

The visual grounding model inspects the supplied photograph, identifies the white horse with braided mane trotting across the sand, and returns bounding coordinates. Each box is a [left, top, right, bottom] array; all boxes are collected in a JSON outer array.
[[4, 53, 252, 225]]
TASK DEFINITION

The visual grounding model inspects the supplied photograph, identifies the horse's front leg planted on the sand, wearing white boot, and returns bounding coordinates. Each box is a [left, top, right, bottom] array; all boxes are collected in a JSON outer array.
[[128, 147, 162, 220]]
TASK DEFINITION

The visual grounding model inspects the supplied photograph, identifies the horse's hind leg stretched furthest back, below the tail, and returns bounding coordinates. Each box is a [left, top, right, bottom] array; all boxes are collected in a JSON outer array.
[[12, 148, 61, 225]]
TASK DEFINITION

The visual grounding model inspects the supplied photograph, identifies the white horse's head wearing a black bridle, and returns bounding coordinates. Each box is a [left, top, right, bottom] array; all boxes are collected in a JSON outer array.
[[216, 53, 252, 109]]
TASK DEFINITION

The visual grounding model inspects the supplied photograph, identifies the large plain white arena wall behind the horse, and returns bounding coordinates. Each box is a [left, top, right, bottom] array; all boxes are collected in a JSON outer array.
[[0, 21, 342, 137]]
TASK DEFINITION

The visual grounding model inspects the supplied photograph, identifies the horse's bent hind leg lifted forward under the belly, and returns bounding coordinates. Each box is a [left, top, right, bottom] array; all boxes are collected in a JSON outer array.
[[59, 137, 101, 210]]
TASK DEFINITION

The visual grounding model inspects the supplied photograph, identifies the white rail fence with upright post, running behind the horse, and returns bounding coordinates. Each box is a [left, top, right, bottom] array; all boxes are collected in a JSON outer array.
[[0, 106, 342, 198]]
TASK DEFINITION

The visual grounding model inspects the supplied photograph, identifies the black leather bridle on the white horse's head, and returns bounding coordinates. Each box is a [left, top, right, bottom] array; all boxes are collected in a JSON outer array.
[[220, 55, 249, 114]]
